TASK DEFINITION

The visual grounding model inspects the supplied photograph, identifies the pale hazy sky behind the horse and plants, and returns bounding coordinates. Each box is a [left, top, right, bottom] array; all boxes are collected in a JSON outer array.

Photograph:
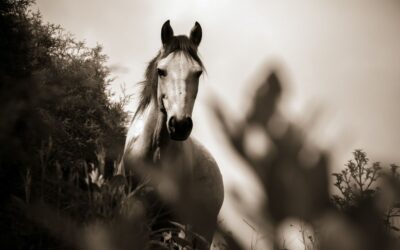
[[37, 0, 400, 248]]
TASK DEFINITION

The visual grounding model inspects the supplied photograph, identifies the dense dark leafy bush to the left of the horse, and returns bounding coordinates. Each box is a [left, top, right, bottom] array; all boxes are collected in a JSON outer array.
[[0, 0, 128, 249]]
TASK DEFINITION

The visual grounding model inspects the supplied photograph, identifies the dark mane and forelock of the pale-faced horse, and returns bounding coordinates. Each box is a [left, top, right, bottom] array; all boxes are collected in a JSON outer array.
[[133, 35, 204, 120]]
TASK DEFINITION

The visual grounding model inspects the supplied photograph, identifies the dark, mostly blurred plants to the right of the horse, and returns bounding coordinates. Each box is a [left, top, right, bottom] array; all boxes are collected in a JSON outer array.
[[214, 69, 400, 250]]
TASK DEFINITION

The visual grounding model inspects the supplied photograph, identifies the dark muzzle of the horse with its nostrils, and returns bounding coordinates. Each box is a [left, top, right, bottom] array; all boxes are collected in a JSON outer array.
[[167, 116, 193, 141]]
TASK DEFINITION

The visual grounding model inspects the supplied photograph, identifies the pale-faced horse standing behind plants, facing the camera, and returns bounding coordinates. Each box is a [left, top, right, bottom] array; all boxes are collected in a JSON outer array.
[[122, 20, 224, 248]]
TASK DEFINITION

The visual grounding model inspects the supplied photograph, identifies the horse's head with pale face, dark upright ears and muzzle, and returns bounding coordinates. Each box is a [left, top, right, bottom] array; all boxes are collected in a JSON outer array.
[[157, 20, 203, 141]]
